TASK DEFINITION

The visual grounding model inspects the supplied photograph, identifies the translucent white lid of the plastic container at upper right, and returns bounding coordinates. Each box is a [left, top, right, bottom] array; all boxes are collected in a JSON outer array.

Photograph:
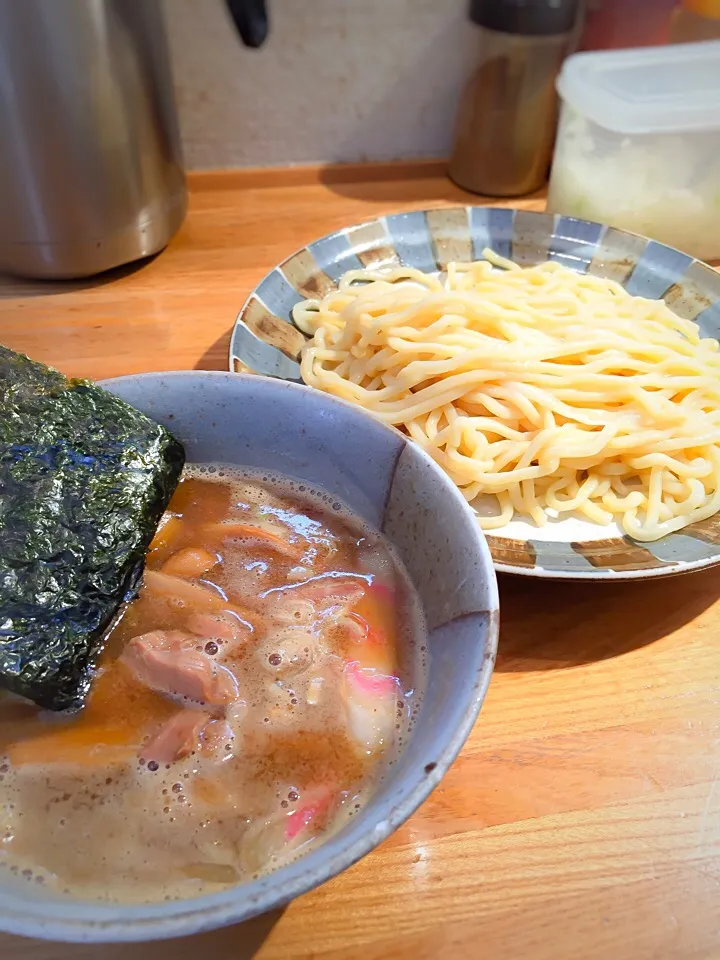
[[557, 40, 720, 134]]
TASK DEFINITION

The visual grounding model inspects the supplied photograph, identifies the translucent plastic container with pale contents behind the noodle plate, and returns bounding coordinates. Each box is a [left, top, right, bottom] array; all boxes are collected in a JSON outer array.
[[548, 40, 720, 260]]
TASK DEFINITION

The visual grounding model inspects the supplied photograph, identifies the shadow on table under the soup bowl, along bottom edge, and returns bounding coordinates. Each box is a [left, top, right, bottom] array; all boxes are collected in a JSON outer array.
[[0, 909, 283, 960]]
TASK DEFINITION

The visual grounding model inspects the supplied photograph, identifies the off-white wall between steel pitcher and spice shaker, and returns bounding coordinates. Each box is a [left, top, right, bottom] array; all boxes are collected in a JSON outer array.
[[164, 0, 477, 169]]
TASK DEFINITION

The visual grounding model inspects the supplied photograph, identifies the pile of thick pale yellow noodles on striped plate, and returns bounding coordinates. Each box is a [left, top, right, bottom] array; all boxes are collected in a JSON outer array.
[[293, 251, 720, 540]]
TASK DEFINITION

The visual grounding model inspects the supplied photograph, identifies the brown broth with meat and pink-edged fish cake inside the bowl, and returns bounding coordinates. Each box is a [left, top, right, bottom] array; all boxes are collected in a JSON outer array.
[[0, 465, 426, 902]]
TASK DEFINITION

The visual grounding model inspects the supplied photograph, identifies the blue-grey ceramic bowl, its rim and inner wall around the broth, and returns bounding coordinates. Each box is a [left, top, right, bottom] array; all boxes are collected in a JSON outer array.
[[0, 371, 498, 941]]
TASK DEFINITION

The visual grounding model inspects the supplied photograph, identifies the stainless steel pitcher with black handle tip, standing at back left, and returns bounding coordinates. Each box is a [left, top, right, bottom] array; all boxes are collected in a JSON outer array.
[[0, 0, 267, 277]]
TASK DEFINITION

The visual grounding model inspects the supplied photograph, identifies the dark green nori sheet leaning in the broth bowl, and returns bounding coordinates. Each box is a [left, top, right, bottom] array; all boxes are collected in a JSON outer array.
[[0, 346, 185, 710]]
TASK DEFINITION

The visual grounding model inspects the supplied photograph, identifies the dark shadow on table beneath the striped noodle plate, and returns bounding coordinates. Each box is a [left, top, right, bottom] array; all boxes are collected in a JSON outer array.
[[496, 567, 720, 673]]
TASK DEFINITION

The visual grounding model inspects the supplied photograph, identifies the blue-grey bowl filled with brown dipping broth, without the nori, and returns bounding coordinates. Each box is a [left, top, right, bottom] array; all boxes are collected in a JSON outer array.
[[0, 371, 498, 941]]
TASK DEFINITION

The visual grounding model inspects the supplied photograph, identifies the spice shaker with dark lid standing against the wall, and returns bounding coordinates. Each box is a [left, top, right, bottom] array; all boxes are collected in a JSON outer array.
[[448, 0, 580, 197]]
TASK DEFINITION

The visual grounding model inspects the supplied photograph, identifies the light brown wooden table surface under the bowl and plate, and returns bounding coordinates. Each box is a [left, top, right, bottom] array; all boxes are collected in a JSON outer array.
[[0, 164, 720, 960]]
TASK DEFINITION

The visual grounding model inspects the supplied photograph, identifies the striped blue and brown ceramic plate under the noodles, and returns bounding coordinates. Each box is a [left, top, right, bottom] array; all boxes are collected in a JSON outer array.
[[230, 207, 720, 580]]
